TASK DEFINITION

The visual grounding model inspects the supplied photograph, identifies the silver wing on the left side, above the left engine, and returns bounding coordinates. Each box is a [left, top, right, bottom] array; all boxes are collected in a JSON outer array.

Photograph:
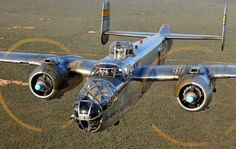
[[0, 51, 97, 75]]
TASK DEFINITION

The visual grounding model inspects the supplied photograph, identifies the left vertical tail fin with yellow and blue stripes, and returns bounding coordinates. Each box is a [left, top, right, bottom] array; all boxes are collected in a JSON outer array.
[[101, 0, 111, 44]]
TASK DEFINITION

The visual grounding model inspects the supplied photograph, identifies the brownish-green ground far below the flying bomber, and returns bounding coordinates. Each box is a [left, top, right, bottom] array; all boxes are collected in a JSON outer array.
[[0, 0, 236, 148]]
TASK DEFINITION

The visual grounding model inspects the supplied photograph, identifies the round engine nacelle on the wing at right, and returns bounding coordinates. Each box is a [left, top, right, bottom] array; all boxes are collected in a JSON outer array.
[[174, 75, 213, 112]]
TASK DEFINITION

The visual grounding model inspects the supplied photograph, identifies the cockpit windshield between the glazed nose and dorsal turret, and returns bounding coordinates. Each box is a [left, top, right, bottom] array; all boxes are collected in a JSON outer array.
[[92, 64, 123, 78]]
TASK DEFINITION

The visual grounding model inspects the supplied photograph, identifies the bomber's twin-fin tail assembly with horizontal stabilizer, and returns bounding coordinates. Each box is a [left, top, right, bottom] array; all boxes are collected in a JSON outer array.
[[101, 0, 228, 51]]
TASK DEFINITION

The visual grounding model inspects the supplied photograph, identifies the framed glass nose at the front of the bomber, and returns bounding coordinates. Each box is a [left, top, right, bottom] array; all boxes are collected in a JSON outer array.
[[72, 79, 116, 132]]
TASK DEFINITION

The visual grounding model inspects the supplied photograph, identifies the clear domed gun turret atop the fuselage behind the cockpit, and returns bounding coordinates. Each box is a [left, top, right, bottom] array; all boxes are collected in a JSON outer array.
[[109, 41, 135, 59]]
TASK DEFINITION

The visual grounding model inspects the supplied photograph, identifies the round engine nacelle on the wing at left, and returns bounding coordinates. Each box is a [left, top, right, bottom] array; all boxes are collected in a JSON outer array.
[[29, 65, 82, 100]]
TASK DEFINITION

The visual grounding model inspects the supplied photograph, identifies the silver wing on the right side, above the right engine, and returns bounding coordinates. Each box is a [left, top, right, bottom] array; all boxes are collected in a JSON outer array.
[[133, 65, 236, 81]]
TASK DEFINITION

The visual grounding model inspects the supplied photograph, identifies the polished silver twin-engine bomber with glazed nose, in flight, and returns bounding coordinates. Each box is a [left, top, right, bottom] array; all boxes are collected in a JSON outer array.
[[0, 0, 232, 132]]
